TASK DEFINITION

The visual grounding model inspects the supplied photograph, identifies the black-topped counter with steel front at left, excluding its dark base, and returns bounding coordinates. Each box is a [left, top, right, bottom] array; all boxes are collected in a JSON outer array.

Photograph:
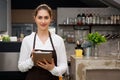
[[0, 42, 21, 71]]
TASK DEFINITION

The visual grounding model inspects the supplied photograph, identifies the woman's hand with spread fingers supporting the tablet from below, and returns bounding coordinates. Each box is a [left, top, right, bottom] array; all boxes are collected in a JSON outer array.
[[37, 58, 55, 70]]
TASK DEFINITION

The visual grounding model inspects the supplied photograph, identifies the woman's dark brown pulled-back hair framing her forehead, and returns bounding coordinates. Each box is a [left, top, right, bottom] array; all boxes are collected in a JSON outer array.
[[34, 4, 53, 18]]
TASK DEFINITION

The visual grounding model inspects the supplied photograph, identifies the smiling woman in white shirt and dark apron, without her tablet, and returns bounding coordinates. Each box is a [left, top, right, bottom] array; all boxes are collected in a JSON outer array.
[[18, 4, 67, 80]]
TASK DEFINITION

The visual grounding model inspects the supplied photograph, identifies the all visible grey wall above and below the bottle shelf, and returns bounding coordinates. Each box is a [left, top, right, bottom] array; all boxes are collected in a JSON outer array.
[[57, 7, 120, 58]]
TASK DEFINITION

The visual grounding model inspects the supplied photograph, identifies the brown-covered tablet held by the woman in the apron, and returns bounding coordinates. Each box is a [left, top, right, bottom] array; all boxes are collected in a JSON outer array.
[[33, 52, 52, 65]]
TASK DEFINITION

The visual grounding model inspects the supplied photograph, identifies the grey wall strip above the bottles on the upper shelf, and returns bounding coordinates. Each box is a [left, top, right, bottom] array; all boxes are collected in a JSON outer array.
[[57, 7, 120, 24]]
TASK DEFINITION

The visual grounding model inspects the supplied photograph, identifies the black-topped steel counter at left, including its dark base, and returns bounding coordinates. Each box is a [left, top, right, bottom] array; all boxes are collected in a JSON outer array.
[[0, 42, 26, 80]]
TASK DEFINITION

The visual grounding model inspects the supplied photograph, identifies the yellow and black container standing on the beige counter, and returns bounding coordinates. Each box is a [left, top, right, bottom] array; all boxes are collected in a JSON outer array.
[[75, 40, 84, 57]]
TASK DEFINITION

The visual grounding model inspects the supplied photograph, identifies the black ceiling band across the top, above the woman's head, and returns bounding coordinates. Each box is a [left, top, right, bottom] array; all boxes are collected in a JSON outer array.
[[11, 0, 108, 9]]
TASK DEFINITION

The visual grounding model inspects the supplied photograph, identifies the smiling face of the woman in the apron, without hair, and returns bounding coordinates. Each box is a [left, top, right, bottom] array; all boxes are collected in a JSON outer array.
[[34, 9, 51, 31]]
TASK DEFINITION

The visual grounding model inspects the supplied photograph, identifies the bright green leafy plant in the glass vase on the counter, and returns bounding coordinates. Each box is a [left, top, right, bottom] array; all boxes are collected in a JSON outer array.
[[87, 32, 107, 45]]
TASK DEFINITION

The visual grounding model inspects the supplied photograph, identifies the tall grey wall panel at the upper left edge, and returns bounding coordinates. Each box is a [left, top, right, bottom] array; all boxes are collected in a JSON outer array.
[[0, 0, 11, 34]]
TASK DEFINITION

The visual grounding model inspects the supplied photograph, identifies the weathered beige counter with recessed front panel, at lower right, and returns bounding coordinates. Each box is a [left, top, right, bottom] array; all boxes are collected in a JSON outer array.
[[70, 55, 120, 80]]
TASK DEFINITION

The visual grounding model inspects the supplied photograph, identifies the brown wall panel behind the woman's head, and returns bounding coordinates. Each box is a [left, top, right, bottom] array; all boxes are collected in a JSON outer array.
[[11, 9, 56, 23]]
